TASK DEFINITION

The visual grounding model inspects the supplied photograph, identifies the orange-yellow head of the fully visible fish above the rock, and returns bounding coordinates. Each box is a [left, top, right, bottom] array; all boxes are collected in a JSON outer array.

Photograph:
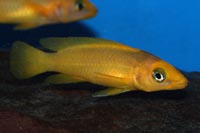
[[136, 59, 188, 92]]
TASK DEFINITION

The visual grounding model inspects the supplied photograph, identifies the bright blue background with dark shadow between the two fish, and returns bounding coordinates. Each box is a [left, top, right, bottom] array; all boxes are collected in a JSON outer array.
[[0, 0, 200, 71]]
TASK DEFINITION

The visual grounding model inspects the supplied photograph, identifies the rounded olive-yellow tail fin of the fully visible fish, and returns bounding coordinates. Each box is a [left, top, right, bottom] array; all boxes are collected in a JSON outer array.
[[9, 41, 47, 79]]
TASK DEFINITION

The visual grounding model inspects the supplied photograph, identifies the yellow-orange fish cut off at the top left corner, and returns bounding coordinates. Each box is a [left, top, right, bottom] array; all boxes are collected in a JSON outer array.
[[0, 0, 97, 29]]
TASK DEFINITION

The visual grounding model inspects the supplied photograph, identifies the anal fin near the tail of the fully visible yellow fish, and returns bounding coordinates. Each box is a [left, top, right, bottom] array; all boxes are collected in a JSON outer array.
[[46, 74, 84, 84]]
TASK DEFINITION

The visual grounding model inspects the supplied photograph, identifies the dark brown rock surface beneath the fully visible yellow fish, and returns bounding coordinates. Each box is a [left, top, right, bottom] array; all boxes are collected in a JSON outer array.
[[0, 52, 200, 132]]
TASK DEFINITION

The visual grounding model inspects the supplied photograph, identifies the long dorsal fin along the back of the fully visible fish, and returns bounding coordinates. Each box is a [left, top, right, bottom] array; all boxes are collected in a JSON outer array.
[[40, 37, 124, 51]]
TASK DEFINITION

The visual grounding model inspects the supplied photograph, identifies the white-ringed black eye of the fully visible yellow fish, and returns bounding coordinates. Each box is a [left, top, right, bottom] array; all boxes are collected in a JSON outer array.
[[152, 68, 166, 82]]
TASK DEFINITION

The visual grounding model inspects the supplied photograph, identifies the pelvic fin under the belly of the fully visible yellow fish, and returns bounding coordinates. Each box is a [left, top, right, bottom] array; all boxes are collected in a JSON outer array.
[[92, 88, 132, 97]]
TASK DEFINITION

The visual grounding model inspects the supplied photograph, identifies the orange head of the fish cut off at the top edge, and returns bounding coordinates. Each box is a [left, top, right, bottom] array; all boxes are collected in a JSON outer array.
[[56, 0, 97, 23]]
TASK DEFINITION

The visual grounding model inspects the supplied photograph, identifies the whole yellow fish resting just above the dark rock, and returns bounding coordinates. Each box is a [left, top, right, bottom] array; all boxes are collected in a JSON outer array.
[[10, 37, 188, 97]]
